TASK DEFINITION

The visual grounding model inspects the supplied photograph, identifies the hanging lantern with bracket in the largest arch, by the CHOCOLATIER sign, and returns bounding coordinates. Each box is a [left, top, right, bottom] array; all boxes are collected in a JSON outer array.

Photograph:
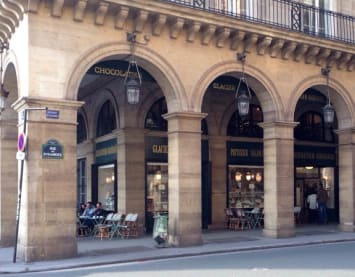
[[124, 33, 142, 105]]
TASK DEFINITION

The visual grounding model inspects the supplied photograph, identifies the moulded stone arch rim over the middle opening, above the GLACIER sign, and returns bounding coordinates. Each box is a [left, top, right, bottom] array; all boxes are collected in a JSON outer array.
[[191, 61, 284, 121]]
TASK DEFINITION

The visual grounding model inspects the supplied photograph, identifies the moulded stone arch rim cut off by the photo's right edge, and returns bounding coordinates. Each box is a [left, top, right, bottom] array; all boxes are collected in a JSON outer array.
[[285, 75, 355, 129]]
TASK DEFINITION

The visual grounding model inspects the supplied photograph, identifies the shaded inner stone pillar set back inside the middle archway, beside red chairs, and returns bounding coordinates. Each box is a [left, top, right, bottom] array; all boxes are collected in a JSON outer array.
[[209, 137, 227, 229]]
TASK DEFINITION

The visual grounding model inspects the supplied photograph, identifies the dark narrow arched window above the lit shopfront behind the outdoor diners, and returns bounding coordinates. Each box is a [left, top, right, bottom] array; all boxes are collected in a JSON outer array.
[[96, 101, 117, 137]]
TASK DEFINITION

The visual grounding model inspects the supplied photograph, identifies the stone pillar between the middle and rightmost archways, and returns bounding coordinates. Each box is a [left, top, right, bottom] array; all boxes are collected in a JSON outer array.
[[260, 122, 297, 238]]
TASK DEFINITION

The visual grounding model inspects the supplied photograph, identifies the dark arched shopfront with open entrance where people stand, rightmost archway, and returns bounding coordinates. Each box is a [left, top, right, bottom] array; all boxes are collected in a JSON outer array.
[[294, 88, 339, 224]]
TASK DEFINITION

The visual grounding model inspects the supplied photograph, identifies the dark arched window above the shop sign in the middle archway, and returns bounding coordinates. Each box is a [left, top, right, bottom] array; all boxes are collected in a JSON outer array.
[[227, 104, 263, 138]]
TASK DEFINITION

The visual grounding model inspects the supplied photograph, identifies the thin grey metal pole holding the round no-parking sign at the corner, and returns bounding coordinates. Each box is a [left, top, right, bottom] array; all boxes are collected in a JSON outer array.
[[12, 107, 48, 263]]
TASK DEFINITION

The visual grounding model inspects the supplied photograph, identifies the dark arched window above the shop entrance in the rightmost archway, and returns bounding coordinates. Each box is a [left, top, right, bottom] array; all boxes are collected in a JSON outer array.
[[295, 111, 335, 143]]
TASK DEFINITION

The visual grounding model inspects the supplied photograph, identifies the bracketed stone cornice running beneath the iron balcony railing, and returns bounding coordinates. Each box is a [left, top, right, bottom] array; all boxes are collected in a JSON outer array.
[[4, 0, 355, 71]]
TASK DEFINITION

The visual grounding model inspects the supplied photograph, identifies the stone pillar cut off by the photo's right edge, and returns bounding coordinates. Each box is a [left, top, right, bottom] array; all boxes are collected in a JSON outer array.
[[337, 129, 355, 232]]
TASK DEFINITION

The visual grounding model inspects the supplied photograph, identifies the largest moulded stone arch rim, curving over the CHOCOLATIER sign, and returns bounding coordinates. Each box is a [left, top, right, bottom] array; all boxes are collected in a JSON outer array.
[[65, 42, 189, 112]]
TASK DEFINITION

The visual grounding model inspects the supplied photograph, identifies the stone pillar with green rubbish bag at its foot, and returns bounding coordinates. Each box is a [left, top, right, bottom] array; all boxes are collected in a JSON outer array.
[[165, 112, 205, 246]]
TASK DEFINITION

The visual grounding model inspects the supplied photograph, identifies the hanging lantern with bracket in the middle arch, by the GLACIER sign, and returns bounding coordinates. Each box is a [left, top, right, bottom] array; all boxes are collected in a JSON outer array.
[[235, 52, 251, 117]]
